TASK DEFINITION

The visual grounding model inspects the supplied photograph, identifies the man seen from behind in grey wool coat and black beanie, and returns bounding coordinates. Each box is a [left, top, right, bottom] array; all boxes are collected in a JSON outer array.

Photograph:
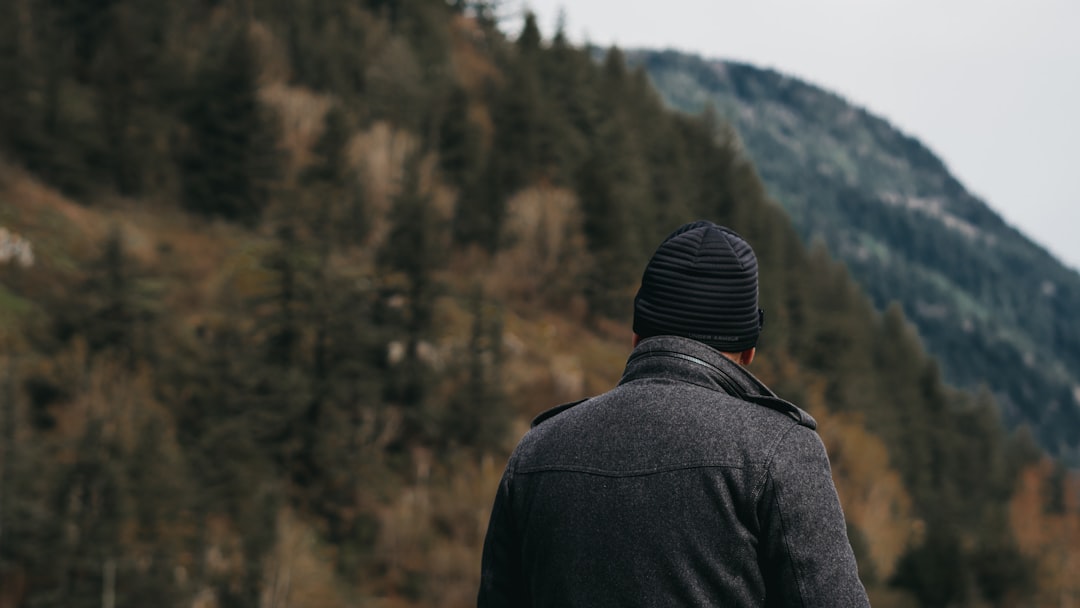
[[478, 221, 869, 608]]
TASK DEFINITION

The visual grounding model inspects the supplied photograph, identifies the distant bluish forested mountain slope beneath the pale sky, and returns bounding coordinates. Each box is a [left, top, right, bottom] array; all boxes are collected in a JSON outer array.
[[626, 51, 1080, 464]]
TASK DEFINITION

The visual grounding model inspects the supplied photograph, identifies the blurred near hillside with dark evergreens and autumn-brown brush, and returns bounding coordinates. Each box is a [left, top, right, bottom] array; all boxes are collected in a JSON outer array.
[[0, 0, 1080, 608]]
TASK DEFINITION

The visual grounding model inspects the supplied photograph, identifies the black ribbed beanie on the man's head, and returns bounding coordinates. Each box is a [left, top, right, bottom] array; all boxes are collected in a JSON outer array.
[[634, 220, 762, 352]]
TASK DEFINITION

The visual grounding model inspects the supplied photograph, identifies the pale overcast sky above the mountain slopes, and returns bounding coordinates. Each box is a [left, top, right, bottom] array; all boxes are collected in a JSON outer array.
[[504, 0, 1080, 269]]
